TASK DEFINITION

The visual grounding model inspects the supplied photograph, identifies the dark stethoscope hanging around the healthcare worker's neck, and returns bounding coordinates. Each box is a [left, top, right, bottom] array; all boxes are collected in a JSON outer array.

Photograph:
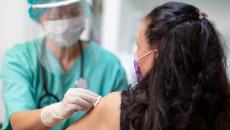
[[38, 41, 88, 108]]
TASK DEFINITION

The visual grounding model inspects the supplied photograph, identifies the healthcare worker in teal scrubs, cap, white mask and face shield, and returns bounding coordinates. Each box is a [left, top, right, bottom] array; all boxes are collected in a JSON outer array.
[[2, 0, 128, 130]]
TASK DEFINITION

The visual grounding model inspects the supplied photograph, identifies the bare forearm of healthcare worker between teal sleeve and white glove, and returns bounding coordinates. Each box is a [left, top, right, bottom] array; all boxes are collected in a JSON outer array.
[[10, 110, 50, 130]]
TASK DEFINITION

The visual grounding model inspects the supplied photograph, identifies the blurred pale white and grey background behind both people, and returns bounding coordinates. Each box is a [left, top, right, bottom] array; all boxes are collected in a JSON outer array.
[[0, 0, 230, 126]]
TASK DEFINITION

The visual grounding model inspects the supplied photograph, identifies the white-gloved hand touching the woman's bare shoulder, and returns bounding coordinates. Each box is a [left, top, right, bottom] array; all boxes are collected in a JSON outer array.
[[41, 88, 101, 127]]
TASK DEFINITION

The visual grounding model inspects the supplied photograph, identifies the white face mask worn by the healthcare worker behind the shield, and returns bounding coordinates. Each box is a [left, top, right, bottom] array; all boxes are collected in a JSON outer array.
[[44, 16, 85, 47]]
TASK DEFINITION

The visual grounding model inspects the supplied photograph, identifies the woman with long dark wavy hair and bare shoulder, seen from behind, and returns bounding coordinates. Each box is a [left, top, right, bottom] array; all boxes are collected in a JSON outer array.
[[68, 2, 230, 130]]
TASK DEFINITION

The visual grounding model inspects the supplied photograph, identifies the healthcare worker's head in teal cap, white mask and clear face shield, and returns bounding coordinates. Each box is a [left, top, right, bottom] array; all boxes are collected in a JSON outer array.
[[29, 0, 99, 72]]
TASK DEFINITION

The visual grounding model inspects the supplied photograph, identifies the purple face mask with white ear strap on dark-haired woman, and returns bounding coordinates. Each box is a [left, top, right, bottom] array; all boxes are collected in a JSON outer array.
[[134, 51, 153, 82]]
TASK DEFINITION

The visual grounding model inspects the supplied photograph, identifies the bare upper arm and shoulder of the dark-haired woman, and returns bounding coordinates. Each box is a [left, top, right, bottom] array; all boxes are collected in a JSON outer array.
[[67, 92, 121, 130]]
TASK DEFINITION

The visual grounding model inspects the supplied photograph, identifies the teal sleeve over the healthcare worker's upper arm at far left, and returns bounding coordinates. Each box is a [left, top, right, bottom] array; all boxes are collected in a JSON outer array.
[[2, 49, 35, 123]]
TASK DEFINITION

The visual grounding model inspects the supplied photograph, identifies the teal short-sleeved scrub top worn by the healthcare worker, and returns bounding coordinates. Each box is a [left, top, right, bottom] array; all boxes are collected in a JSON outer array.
[[2, 39, 128, 130]]
